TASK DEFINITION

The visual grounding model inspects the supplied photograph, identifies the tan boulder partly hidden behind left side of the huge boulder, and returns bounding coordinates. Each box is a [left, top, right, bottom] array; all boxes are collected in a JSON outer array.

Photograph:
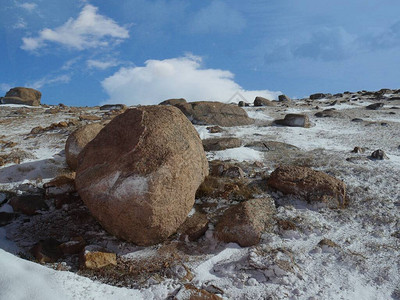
[[65, 123, 104, 171]]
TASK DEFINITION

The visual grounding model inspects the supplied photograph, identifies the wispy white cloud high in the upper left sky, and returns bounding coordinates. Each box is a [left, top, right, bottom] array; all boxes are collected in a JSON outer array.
[[21, 4, 129, 51]]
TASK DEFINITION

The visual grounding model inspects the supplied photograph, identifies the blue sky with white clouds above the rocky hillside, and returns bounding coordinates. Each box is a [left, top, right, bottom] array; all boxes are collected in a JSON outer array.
[[0, 0, 400, 106]]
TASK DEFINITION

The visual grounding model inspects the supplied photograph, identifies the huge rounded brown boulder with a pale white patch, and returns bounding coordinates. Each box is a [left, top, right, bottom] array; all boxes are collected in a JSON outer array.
[[75, 106, 208, 245]]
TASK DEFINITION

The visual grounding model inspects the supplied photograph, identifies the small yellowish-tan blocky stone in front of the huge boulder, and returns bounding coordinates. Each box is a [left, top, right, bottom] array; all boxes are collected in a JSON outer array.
[[82, 245, 117, 270]]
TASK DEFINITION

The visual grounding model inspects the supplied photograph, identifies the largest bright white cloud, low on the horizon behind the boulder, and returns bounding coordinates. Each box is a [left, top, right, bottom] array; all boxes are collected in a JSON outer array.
[[102, 56, 280, 105]]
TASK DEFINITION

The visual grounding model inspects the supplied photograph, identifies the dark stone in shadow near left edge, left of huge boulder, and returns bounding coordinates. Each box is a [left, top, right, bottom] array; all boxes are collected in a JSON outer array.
[[9, 194, 49, 216]]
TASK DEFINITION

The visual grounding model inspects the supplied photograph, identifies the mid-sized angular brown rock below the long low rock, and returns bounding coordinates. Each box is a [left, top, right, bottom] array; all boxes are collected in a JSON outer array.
[[215, 198, 276, 247]]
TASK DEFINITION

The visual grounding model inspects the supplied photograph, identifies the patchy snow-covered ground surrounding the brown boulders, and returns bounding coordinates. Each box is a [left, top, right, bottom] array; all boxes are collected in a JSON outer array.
[[0, 95, 400, 300]]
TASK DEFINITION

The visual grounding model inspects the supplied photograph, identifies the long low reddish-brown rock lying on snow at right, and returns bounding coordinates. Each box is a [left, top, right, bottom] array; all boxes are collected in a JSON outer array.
[[267, 166, 346, 208]]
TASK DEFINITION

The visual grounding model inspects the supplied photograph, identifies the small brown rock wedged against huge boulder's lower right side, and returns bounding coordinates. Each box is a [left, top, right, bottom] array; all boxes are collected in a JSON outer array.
[[177, 211, 209, 242]]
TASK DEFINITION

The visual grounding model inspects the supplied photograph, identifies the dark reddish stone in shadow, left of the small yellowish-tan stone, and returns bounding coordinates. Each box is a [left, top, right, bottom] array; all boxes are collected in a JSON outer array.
[[30, 238, 63, 264]]
